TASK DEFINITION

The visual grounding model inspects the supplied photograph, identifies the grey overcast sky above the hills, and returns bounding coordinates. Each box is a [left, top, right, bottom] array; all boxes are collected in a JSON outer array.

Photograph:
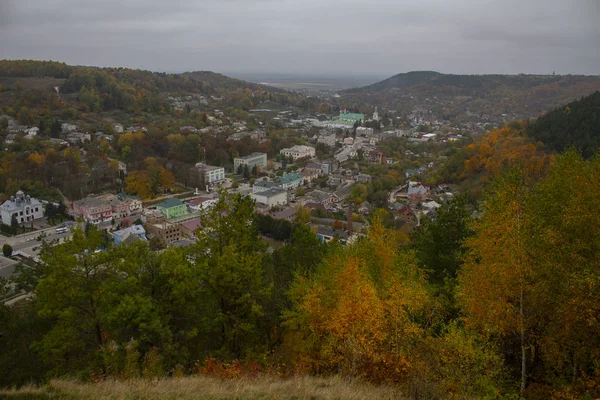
[[0, 0, 600, 76]]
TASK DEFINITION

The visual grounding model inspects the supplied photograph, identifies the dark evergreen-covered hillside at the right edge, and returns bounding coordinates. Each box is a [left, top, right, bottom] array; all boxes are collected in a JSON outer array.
[[527, 92, 600, 157]]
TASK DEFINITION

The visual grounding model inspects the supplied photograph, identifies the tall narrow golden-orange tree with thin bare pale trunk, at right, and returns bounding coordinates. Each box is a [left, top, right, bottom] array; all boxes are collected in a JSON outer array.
[[458, 167, 534, 392]]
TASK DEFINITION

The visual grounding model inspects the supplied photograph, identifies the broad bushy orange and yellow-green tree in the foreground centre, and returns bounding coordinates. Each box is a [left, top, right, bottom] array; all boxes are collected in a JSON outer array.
[[286, 222, 430, 381]]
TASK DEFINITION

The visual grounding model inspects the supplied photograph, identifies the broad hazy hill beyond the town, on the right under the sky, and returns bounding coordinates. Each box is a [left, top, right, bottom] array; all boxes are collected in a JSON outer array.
[[339, 71, 600, 124]]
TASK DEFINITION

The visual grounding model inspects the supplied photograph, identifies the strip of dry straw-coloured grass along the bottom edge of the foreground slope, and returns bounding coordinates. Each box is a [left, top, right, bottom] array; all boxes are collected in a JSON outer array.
[[0, 376, 402, 400]]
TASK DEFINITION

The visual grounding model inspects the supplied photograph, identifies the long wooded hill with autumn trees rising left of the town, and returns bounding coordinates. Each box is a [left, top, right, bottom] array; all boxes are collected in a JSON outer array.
[[0, 60, 313, 116]]
